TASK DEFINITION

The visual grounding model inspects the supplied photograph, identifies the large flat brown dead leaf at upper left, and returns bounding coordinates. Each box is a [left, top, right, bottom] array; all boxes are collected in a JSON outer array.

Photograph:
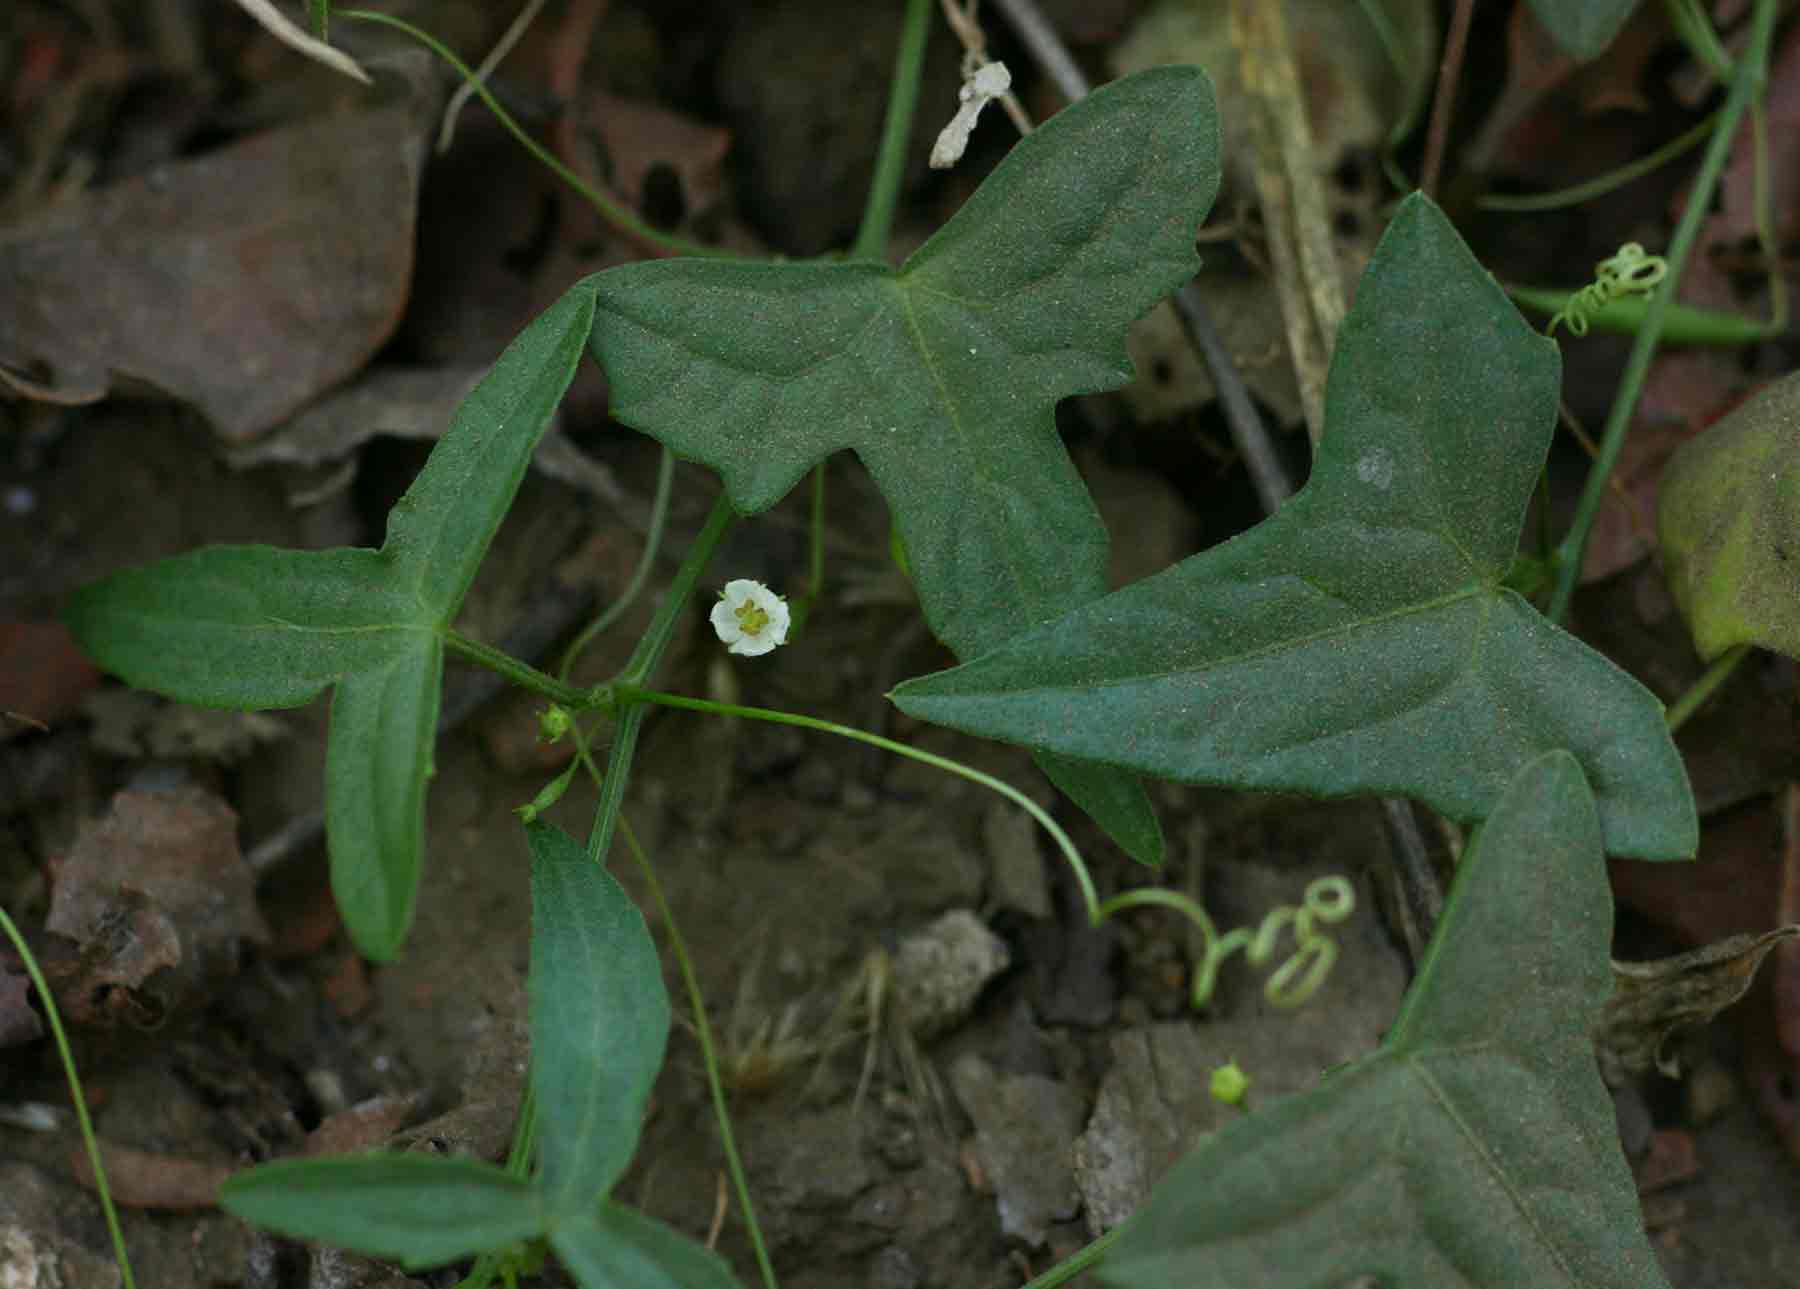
[[0, 50, 434, 441]]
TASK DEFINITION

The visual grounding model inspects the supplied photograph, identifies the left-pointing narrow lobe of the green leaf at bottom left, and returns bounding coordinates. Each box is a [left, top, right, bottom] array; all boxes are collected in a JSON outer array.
[[220, 1154, 544, 1267]]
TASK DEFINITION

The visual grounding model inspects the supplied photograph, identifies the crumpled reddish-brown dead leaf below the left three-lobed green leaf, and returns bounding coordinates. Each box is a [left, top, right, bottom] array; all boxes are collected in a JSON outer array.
[[45, 787, 268, 1026]]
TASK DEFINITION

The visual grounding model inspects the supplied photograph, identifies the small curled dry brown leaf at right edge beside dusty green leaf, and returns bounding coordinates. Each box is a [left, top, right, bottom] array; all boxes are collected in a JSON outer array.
[[1597, 925, 1800, 1082]]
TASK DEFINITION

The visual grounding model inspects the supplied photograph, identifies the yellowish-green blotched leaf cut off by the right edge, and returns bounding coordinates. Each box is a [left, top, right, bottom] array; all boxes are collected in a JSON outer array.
[[1656, 373, 1800, 659]]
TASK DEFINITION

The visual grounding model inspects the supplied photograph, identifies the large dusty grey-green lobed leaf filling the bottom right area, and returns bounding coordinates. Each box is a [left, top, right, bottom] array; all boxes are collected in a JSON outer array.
[[1098, 751, 1667, 1289]]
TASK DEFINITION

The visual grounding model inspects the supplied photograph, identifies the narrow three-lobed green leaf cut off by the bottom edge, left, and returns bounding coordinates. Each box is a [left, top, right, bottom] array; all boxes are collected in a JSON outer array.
[[220, 823, 736, 1289]]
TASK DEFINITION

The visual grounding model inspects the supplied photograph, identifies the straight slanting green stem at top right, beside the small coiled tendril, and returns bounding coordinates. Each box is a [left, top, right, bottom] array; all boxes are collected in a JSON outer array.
[[1550, 0, 1777, 623]]
